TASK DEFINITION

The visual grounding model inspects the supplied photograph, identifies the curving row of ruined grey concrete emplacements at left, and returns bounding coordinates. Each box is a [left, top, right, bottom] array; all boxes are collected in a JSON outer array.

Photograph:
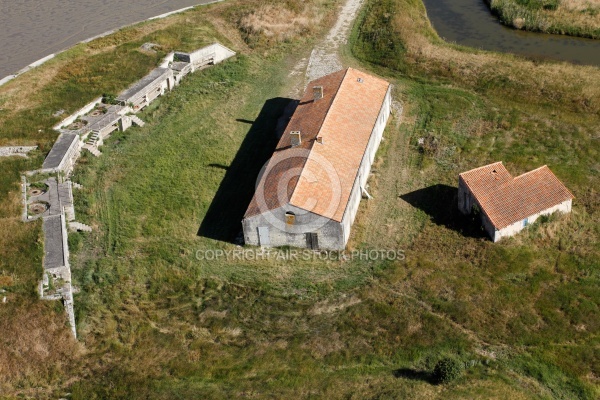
[[23, 43, 236, 337]]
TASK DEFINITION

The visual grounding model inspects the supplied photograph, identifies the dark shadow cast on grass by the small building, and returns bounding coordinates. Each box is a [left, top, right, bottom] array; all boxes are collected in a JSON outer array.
[[400, 184, 486, 238]]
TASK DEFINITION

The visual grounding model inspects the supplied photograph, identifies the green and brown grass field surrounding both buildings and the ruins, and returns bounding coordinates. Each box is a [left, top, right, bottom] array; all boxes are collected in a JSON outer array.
[[0, 0, 600, 399]]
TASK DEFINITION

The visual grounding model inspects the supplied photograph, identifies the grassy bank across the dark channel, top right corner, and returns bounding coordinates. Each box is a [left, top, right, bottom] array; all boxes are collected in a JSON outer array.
[[484, 0, 600, 39]]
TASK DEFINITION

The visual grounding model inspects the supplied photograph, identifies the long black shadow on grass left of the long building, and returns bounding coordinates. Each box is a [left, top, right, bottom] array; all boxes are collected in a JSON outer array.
[[198, 97, 295, 243]]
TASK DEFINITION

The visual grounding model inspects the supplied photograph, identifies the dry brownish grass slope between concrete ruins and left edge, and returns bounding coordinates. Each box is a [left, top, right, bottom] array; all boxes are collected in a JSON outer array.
[[0, 7, 239, 397]]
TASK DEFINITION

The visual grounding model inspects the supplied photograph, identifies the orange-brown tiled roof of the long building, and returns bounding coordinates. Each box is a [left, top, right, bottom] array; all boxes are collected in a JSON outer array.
[[245, 68, 390, 221]]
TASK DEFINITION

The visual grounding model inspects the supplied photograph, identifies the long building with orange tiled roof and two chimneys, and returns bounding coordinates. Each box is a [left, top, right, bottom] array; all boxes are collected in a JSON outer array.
[[242, 68, 391, 250]]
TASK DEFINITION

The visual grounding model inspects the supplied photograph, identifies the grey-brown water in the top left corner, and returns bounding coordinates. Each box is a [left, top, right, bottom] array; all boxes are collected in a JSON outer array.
[[0, 0, 216, 78]]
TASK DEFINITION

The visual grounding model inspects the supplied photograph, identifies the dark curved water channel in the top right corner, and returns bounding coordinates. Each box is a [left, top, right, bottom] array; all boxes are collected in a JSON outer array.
[[424, 0, 600, 66]]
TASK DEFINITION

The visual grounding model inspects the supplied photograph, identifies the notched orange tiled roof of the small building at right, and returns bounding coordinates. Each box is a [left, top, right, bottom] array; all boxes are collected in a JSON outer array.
[[460, 162, 574, 229]]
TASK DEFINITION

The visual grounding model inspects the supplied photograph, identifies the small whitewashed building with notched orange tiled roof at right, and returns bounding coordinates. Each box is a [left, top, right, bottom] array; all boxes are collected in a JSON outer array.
[[458, 162, 574, 242]]
